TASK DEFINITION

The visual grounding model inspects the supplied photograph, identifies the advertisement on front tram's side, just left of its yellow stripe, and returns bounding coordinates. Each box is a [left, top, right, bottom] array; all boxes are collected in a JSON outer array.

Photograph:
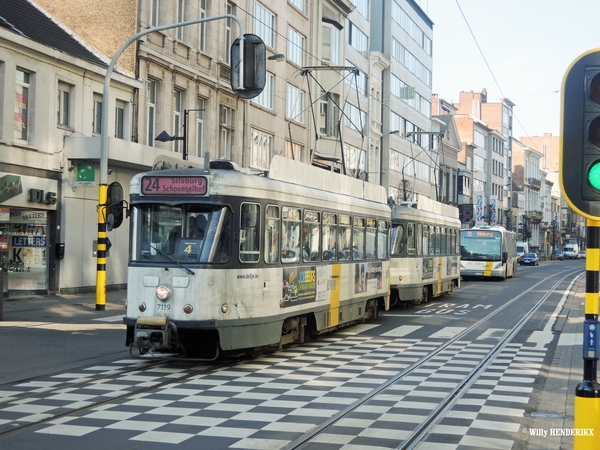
[[280, 266, 327, 308]]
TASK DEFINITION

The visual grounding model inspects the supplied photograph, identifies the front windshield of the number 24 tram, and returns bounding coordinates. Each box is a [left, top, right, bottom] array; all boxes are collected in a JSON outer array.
[[131, 203, 231, 263]]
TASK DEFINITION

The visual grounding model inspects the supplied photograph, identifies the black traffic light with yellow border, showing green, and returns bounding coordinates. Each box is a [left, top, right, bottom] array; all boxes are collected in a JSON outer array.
[[560, 49, 600, 220]]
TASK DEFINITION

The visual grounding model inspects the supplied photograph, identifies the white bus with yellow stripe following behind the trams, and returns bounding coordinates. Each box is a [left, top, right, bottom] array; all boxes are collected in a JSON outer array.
[[460, 226, 518, 280]]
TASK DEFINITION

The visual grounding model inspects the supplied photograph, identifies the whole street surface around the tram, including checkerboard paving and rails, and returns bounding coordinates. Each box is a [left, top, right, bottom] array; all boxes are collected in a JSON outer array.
[[0, 261, 585, 450]]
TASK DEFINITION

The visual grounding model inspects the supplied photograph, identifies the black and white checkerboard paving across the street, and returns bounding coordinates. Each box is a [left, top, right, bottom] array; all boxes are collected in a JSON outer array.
[[0, 330, 545, 450]]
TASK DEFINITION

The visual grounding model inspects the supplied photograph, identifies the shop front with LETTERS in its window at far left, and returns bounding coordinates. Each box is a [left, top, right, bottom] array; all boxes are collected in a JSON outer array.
[[0, 172, 60, 296]]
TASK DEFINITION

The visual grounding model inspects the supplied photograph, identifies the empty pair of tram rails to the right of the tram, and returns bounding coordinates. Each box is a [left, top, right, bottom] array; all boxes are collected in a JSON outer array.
[[285, 270, 582, 450]]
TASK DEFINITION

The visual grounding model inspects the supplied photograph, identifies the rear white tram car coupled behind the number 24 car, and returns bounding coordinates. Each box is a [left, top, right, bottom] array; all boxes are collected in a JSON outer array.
[[390, 198, 460, 305]]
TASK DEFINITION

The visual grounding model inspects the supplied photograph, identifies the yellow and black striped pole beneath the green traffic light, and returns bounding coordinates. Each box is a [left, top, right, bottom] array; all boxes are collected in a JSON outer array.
[[573, 219, 600, 450]]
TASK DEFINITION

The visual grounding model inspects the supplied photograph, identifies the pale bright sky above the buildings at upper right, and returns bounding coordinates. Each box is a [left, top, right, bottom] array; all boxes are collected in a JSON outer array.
[[417, 0, 600, 139]]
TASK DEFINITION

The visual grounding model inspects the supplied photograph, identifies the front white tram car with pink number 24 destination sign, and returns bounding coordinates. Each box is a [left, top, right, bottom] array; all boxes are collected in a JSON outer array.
[[124, 156, 391, 359]]
